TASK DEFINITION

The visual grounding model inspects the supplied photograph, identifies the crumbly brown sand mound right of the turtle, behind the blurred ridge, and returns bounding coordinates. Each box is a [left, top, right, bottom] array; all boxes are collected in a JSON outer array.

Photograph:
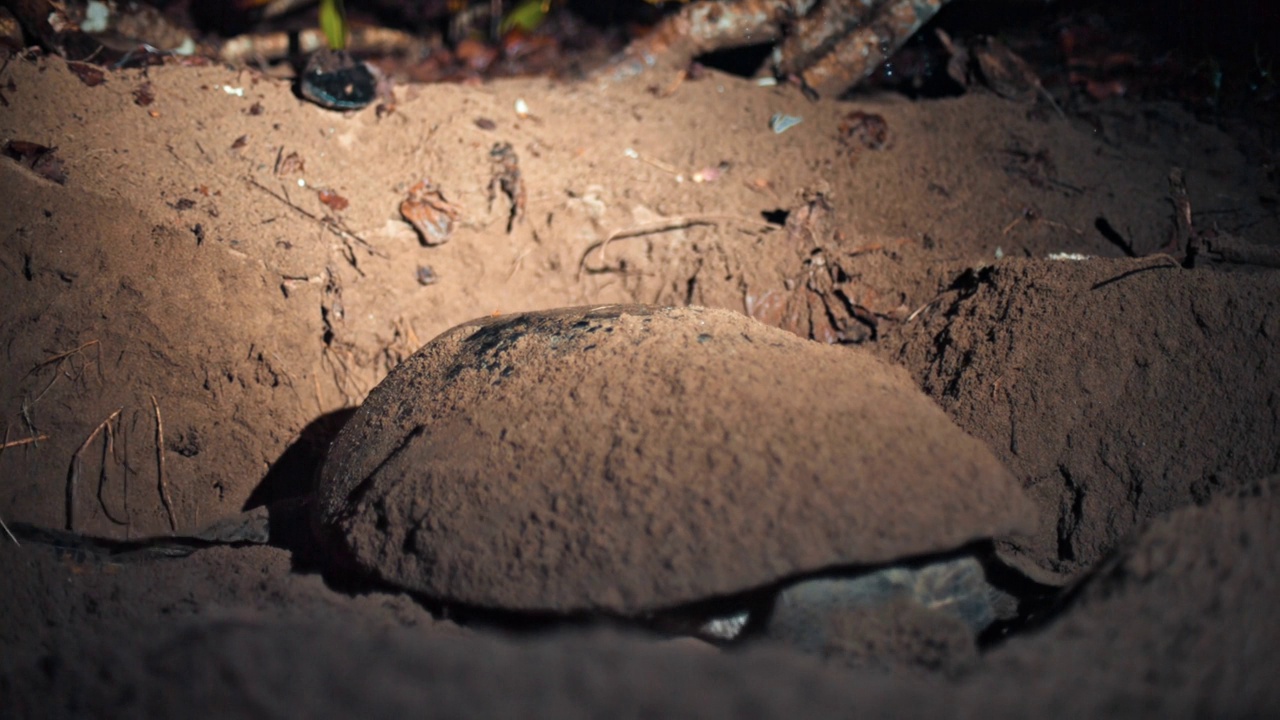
[[900, 258, 1280, 577]]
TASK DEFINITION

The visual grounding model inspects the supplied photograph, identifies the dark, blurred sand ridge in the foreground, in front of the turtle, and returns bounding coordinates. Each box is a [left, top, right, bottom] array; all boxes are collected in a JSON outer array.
[[0, 478, 1280, 719]]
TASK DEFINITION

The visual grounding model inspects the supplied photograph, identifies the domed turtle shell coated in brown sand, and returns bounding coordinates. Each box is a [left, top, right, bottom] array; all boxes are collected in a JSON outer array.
[[316, 305, 1036, 615]]
